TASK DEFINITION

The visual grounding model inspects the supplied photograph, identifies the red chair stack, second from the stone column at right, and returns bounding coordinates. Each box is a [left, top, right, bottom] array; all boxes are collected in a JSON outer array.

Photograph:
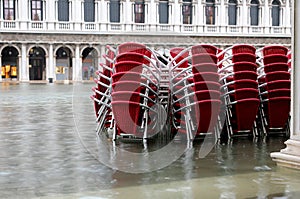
[[218, 44, 260, 138]]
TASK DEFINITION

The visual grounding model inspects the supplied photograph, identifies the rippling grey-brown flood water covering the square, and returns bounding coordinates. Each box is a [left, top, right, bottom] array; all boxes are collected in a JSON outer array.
[[0, 83, 300, 199]]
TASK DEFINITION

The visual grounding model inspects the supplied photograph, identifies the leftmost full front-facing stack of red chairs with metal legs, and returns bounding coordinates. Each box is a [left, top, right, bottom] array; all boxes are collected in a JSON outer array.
[[111, 42, 160, 139]]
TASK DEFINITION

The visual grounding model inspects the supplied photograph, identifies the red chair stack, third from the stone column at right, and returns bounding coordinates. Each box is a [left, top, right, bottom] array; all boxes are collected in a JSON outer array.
[[169, 44, 221, 142]]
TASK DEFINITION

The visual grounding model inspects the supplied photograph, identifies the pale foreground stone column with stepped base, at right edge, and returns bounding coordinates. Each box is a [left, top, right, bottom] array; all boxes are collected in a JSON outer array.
[[271, 1, 300, 169]]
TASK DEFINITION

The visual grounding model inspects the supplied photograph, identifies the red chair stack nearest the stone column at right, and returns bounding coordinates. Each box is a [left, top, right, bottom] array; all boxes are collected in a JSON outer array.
[[258, 45, 291, 135]]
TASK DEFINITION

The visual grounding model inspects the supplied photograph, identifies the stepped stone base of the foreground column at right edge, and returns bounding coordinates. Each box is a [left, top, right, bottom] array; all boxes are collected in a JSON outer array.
[[271, 137, 300, 170]]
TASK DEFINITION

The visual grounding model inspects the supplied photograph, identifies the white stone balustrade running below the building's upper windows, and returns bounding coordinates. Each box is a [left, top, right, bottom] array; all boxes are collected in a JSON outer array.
[[0, 20, 292, 37]]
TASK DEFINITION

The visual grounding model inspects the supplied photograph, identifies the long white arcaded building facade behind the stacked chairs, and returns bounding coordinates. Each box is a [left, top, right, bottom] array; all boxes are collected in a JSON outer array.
[[0, 0, 292, 82]]
